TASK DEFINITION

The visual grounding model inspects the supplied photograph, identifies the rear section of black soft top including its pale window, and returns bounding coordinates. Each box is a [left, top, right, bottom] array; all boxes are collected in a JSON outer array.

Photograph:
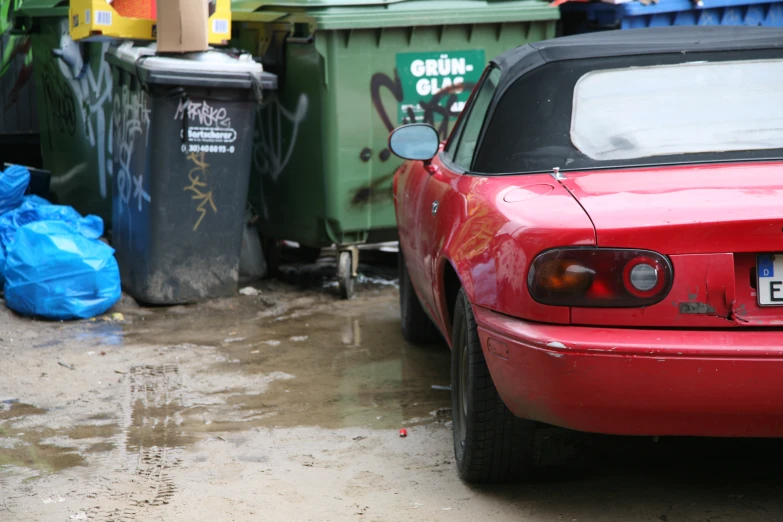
[[471, 47, 783, 175]]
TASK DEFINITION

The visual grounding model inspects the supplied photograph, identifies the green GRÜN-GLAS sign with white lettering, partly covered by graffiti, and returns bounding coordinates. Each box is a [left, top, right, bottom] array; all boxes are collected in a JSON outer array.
[[397, 50, 486, 130]]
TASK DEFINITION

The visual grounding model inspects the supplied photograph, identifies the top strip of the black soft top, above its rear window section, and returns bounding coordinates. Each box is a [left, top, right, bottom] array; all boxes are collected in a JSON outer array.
[[492, 26, 783, 83]]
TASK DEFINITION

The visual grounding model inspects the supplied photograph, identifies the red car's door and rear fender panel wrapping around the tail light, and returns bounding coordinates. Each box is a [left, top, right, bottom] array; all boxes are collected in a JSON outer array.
[[395, 150, 595, 335]]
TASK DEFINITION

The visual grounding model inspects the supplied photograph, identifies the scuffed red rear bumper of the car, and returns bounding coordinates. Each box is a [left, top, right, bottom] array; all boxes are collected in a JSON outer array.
[[475, 307, 783, 437]]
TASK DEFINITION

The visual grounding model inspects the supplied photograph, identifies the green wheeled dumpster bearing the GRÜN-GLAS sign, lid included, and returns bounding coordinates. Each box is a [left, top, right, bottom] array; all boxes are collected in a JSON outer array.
[[232, 0, 559, 297]]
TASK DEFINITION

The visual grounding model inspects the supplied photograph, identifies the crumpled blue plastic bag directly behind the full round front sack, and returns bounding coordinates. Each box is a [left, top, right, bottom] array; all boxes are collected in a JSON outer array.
[[0, 196, 103, 281]]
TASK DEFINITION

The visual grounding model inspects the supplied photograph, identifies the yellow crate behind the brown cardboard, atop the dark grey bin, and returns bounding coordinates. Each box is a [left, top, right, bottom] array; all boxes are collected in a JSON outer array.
[[68, 0, 231, 45]]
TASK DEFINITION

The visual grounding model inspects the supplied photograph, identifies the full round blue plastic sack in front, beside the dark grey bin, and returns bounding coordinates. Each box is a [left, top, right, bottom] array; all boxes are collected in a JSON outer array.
[[5, 216, 122, 320]]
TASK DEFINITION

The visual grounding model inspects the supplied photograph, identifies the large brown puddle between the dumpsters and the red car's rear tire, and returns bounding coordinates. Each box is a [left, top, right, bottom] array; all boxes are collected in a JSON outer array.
[[126, 292, 450, 431]]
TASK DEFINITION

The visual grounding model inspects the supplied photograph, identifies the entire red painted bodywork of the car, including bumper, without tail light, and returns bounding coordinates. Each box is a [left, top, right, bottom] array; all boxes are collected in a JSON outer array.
[[395, 157, 783, 436]]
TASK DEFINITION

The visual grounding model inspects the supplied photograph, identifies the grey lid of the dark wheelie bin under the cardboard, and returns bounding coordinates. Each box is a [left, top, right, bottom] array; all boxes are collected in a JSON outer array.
[[106, 42, 277, 90]]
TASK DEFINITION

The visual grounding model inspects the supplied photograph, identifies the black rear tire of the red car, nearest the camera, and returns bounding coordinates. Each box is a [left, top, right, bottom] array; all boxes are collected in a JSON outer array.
[[451, 290, 536, 484]]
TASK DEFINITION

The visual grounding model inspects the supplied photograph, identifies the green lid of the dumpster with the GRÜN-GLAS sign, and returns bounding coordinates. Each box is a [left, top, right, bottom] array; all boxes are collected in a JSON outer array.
[[231, 0, 560, 30]]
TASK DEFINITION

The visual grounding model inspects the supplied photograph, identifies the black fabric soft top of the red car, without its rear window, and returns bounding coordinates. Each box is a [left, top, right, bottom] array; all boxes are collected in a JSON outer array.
[[469, 26, 783, 175]]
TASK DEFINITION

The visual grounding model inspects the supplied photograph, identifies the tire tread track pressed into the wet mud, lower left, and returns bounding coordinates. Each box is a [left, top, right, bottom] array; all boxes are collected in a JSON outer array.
[[87, 365, 182, 522]]
